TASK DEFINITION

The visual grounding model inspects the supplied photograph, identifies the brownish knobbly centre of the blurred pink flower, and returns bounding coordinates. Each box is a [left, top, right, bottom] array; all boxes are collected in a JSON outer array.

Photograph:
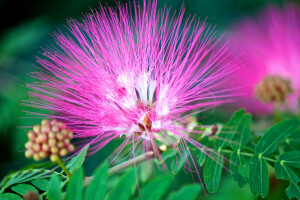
[[255, 75, 293, 103]]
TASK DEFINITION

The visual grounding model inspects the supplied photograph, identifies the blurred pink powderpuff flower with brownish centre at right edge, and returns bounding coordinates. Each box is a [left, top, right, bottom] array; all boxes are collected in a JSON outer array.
[[232, 4, 300, 114]]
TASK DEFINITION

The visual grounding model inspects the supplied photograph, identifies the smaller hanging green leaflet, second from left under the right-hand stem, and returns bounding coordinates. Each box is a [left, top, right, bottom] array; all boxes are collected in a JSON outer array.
[[230, 151, 249, 187]]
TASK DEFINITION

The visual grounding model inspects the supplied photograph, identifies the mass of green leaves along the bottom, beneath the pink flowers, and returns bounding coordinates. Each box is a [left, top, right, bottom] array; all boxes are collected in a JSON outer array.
[[0, 109, 300, 200]]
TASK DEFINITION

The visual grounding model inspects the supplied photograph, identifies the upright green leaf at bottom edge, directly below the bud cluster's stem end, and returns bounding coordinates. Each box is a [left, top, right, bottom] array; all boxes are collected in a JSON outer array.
[[66, 167, 83, 200]]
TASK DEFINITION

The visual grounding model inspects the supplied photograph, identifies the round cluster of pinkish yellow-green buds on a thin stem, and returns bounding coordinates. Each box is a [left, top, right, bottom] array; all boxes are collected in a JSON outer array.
[[25, 119, 74, 162]]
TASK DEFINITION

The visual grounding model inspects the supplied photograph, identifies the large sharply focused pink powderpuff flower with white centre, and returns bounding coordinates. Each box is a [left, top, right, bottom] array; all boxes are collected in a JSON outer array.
[[27, 1, 236, 184]]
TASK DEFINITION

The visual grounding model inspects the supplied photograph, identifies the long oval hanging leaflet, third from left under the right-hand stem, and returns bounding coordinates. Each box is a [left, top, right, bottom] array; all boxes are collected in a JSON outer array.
[[249, 154, 269, 198]]
